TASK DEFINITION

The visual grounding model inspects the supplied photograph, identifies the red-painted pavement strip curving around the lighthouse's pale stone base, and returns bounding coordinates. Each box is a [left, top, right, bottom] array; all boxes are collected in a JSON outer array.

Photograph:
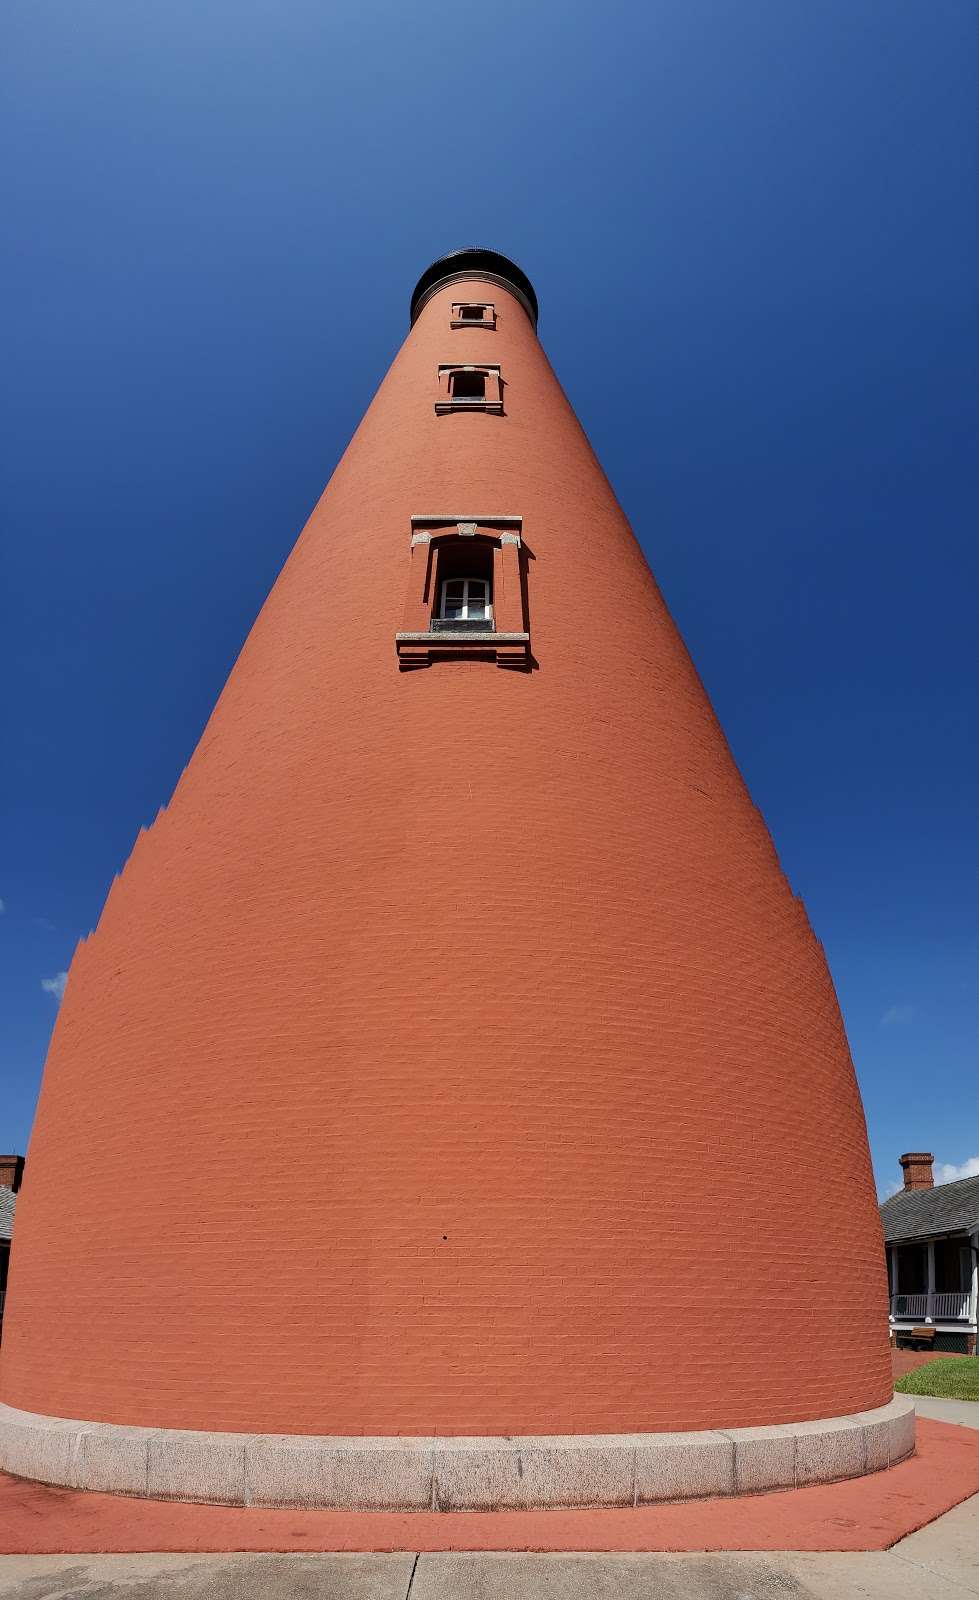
[[0, 1419, 979, 1555]]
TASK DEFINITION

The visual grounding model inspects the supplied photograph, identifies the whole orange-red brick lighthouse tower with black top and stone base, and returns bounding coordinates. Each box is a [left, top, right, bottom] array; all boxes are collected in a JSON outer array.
[[0, 250, 913, 1507]]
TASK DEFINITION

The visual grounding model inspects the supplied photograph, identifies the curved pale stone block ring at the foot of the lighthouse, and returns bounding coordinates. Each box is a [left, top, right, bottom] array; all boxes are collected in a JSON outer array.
[[0, 1395, 915, 1510]]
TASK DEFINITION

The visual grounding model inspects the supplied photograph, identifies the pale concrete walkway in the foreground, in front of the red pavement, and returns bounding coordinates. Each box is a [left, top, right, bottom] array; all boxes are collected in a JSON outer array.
[[0, 1496, 979, 1600]]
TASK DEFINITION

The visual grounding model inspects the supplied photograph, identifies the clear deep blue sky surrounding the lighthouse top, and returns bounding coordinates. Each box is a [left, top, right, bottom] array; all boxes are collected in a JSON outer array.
[[0, 0, 979, 1187]]
